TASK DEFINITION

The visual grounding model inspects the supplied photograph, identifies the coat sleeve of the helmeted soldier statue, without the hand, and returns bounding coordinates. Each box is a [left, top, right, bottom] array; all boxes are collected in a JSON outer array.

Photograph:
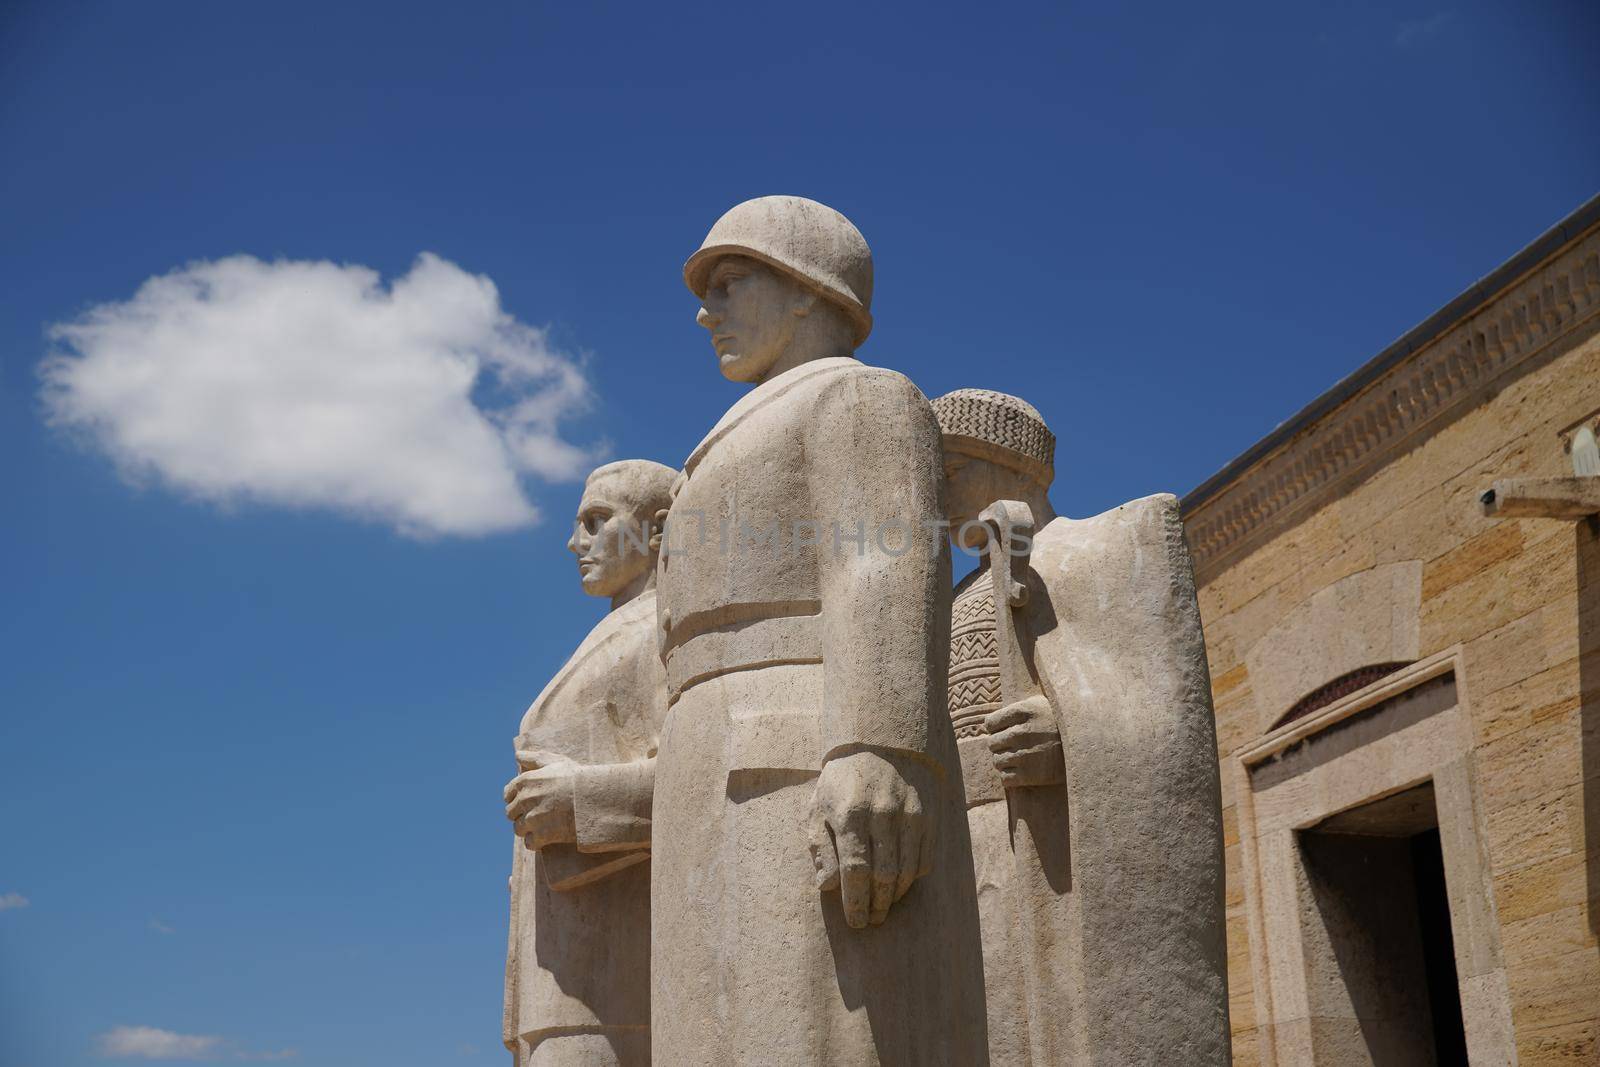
[[806, 371, 950, 758]]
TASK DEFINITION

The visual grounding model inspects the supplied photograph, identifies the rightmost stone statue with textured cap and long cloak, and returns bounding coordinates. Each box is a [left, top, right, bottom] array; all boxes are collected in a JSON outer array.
[[934, 390, 1230, 1067]]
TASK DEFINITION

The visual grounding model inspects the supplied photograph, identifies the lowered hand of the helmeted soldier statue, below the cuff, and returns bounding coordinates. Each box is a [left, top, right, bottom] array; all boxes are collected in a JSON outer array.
[[810, 752, 933, 929]]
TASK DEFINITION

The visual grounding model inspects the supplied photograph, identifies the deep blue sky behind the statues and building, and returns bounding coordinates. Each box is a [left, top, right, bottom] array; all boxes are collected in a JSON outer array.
[[0, 0, 1600, 1067]]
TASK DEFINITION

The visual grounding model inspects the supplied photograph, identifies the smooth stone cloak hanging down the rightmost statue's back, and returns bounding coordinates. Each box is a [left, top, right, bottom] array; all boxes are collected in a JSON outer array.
[[1026, 494, 1232, 1064]]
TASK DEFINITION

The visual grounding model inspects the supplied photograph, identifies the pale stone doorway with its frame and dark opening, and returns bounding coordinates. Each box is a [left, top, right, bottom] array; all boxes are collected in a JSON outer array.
[[1234, 649, 1517, 1067]]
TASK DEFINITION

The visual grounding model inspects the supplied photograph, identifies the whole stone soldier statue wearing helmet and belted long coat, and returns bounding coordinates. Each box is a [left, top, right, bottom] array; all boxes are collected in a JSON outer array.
[[651, 197, 986, 1067]]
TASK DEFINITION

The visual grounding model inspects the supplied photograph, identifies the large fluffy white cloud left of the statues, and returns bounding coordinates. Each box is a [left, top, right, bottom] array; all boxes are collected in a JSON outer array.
[[40, 253, 597, 536]]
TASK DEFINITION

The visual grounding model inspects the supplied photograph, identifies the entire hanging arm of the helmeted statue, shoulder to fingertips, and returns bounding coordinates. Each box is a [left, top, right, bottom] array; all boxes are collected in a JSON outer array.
[[806, 373, 950, 928]]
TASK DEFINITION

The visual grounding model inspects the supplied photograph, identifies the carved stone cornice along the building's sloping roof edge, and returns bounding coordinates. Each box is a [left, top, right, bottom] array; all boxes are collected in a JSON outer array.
[[1182, 197, 1600, 582]]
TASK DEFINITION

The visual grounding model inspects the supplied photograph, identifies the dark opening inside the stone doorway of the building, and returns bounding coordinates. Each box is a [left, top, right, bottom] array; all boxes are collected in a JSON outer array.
[[1299, 782, 1467, 1067]]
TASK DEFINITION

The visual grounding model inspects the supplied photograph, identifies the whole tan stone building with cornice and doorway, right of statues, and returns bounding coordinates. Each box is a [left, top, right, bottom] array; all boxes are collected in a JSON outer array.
[[1184, 197, 1600, 1067]]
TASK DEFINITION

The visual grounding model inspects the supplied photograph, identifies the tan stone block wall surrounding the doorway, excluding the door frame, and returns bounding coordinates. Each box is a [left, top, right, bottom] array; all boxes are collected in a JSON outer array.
[[1186, 214, 1600, 1067]]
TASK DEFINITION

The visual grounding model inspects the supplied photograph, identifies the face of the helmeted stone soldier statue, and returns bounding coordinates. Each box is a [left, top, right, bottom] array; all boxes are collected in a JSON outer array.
[[694, 256, 814, 382]]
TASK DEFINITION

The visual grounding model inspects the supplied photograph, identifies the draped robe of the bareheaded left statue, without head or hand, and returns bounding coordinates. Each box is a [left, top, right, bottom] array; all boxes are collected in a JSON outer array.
[[504, 590, 666, 1067]]
